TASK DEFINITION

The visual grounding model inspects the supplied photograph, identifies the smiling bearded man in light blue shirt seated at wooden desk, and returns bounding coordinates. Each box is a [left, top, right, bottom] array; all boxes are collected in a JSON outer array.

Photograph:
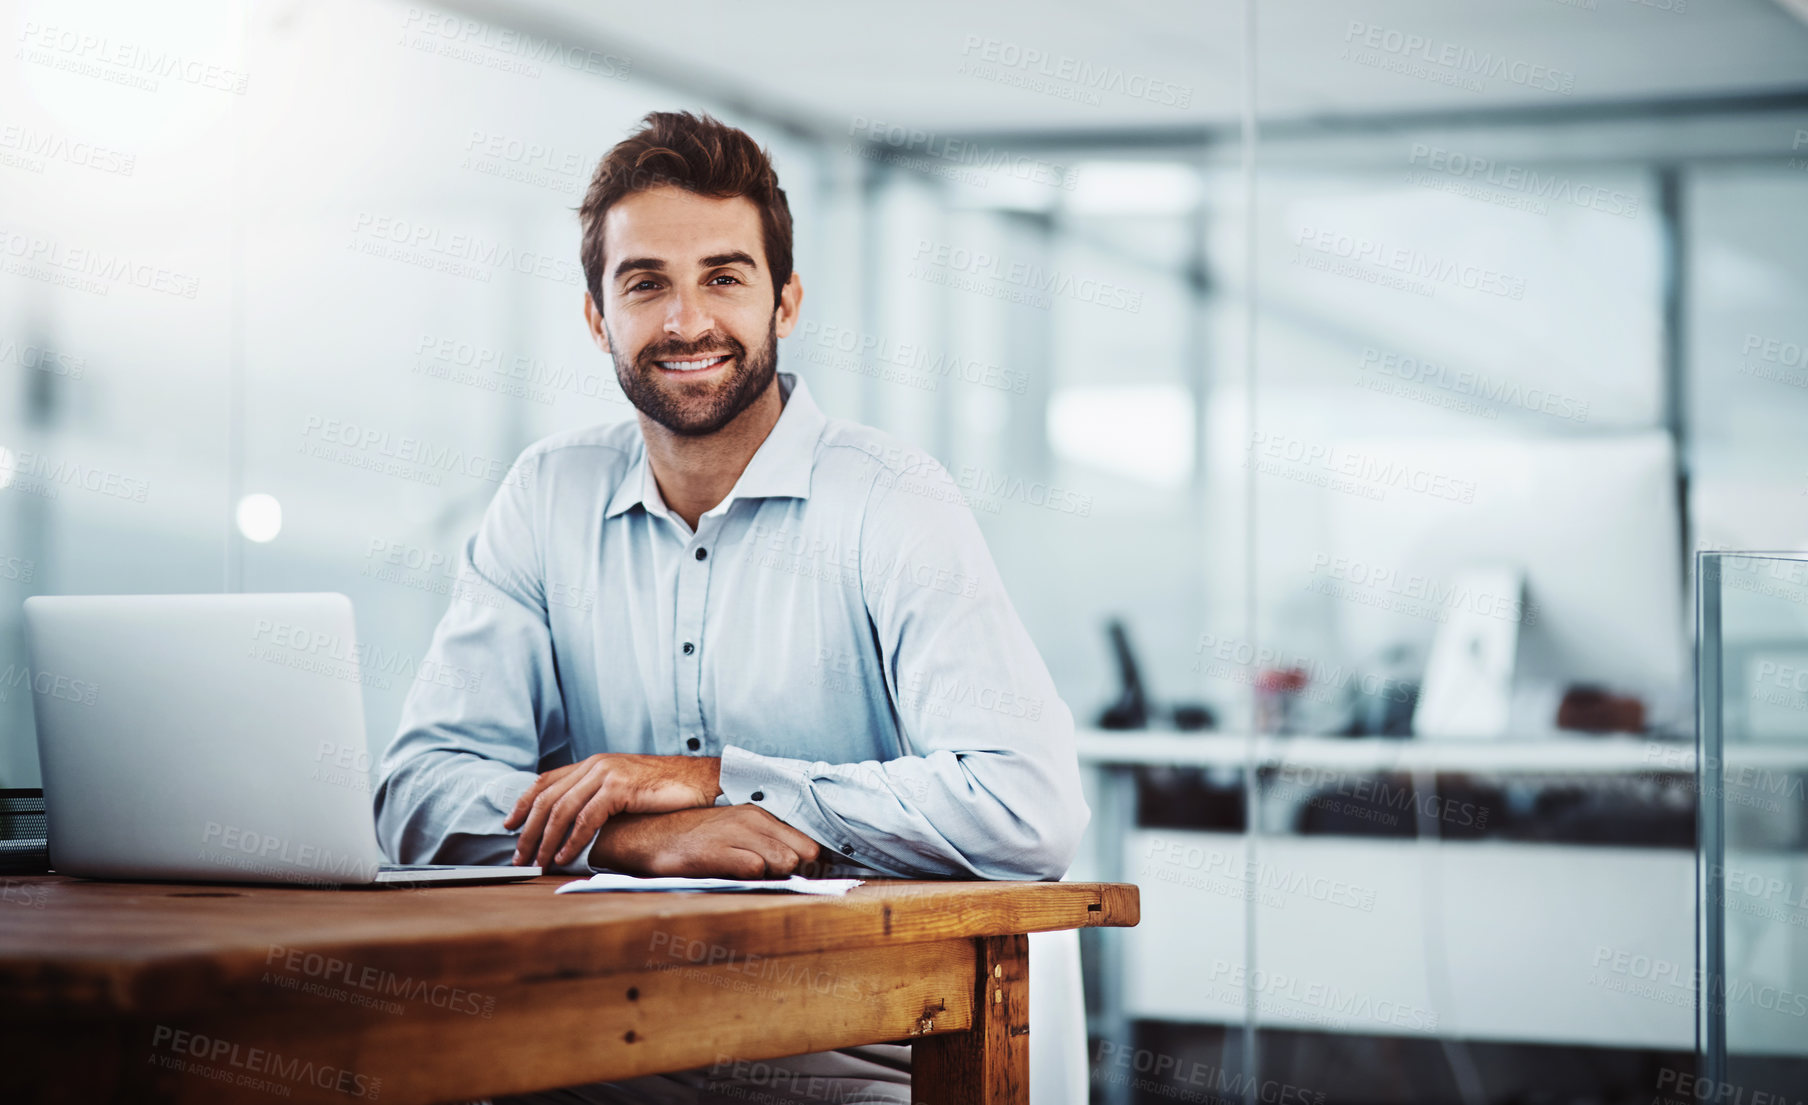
[[376, 112, 1087, 1101]]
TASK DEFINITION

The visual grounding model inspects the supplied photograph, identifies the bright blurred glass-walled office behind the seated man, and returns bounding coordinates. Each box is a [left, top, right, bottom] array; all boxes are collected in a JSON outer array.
[[0, 0, 1808, 1105]]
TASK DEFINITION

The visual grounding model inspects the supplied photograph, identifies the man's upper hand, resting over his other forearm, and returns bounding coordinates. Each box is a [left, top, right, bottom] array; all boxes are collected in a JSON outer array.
[[503, 752, 721, 866]]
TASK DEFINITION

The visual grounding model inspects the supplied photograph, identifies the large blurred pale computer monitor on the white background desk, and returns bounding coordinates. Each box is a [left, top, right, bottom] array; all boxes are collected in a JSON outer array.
[[1314, 432, 1687, 727]]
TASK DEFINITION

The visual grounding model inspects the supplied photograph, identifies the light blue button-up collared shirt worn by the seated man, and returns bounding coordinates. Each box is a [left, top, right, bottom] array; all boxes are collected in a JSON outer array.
[[376, 373, 1088, 879]]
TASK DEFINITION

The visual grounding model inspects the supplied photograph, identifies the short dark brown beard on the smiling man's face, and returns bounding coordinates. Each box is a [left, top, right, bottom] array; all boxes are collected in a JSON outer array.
[[609, 311, 779, 438]]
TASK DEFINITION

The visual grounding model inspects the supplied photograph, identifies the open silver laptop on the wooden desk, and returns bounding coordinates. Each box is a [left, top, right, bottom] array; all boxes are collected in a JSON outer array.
[[25, 595, 541, 886]]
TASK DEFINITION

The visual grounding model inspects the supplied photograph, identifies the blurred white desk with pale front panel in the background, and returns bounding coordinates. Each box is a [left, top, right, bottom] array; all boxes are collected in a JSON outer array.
[[1072, 731, 1808, 1054]]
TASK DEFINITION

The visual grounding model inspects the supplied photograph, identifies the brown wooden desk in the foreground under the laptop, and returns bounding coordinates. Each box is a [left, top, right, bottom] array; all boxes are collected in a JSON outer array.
[[0, 875, 1139, 1105]]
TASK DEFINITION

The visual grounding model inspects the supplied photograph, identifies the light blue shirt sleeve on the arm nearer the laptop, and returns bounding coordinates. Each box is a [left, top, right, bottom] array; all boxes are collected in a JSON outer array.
[[374, 450, 591, 874]]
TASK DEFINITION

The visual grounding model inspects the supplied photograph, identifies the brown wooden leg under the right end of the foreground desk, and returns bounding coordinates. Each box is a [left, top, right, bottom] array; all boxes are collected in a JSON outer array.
[[911, 935, 1029, 1105]]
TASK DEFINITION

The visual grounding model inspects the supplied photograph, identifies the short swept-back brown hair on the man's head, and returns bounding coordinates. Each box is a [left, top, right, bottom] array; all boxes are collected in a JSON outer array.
[[577, 112, 792, 311]]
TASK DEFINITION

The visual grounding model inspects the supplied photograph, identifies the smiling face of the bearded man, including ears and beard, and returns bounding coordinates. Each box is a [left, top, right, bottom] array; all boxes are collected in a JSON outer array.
[[584, 186, 803, 438]]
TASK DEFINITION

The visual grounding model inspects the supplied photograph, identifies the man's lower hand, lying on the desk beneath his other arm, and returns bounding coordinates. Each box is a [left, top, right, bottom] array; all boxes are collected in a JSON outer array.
[[589, 805, 821, 879]]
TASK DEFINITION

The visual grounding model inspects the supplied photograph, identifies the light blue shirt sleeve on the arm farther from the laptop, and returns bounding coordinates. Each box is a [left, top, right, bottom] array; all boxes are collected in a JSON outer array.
[[721, 452, 1090, 879]]
